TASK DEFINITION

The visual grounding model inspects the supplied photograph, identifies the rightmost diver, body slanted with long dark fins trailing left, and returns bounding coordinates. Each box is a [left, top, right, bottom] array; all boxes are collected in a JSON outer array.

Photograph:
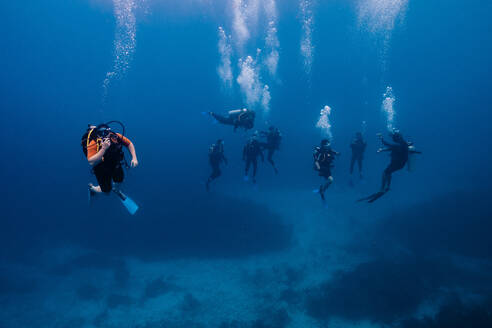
[[358, 130, 422, 203]]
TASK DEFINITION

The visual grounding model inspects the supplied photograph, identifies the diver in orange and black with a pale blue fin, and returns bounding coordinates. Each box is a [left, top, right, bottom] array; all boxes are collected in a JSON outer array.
[[81, 121, 138, 214]]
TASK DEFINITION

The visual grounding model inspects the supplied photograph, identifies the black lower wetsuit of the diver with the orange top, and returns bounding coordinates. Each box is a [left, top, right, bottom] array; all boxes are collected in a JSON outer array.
[[92, 143, 125, 193]]
